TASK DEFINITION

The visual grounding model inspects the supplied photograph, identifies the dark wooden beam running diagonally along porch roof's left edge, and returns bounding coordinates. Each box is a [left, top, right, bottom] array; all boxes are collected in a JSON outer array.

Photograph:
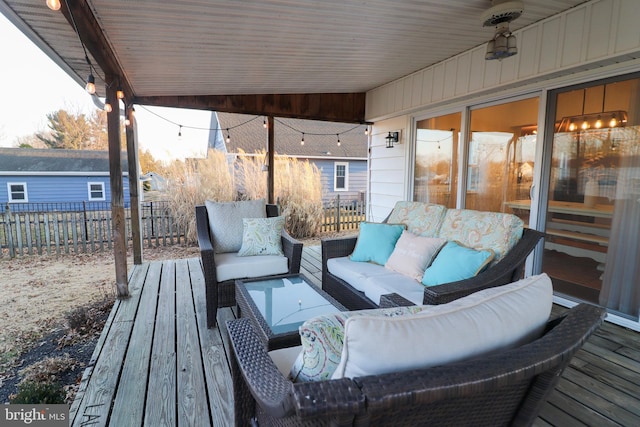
[[61, 0, 135, 99]]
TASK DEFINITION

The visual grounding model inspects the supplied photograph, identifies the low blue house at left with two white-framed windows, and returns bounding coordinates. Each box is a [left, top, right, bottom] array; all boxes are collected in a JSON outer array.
[[0, 148, 129, 209]]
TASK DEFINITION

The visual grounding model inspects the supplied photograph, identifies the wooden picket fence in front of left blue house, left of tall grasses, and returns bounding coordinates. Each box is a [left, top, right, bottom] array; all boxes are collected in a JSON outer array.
[[0, 202, 185, 258]]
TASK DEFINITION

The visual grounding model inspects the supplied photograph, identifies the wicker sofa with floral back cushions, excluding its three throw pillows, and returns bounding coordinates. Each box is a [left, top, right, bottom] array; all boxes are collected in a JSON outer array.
[[321, 202, 544, 310]]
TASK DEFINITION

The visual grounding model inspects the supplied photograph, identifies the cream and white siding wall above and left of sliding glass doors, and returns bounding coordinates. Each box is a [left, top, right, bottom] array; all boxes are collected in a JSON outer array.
[[366, 0, 640, 221]]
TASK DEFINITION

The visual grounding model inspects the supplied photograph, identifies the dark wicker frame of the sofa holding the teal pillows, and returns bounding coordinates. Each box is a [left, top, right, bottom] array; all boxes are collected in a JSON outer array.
[[321, 228, 544, 310]]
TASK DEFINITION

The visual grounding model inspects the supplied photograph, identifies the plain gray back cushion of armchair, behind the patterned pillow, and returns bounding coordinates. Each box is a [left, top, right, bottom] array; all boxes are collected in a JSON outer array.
[[205, 199, 267, 253]]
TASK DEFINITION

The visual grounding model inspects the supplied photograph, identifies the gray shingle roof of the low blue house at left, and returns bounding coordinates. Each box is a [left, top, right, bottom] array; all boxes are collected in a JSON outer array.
[[0, 148, 127, 173]]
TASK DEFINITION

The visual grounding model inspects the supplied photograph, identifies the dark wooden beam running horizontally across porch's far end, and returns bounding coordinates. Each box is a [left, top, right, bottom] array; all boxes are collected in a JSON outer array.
[[133, 92, 366, 124]]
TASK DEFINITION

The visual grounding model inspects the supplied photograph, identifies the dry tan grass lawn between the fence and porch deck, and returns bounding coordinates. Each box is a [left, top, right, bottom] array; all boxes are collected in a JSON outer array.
[[0, 245, 199, 376]]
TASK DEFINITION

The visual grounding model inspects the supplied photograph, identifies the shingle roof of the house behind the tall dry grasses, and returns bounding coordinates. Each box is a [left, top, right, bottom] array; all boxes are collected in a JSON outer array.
[[218, 113, 368, 158]]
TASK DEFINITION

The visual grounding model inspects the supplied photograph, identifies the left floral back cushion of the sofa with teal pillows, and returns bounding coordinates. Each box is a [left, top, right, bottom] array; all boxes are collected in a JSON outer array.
[[387, 201, 447, 237]]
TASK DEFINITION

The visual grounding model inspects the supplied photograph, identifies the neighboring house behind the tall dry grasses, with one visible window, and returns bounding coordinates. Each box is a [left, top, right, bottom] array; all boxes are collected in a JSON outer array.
[[214, 113, 368, 203]]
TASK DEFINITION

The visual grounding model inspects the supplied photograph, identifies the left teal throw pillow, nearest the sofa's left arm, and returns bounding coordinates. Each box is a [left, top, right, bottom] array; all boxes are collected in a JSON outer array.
[[350, 222, 405, 265]]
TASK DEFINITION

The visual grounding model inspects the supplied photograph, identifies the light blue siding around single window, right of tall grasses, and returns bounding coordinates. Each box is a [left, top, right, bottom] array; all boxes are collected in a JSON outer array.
[[309, 159, 367, 203]]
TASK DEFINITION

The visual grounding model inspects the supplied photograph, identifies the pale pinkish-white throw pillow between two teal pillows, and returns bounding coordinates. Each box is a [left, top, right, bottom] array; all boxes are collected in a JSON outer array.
[[384, 230, 447, 282]]
